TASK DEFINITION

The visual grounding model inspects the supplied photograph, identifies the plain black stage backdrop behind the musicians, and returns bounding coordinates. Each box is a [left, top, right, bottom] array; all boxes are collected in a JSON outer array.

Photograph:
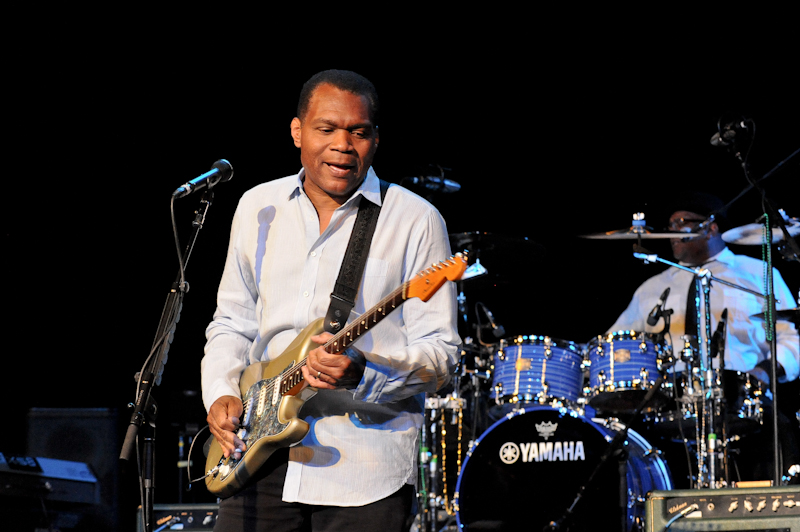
[[0, 15, 800, 532]]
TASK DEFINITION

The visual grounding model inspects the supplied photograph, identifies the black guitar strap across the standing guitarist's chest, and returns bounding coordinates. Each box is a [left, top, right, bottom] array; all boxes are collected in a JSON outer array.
[[324, 179, 389, 334]]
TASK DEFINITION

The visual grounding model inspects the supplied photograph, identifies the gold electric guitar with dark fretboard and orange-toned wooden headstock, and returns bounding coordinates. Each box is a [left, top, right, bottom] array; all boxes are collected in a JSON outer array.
[[205, 253, 467, 498]]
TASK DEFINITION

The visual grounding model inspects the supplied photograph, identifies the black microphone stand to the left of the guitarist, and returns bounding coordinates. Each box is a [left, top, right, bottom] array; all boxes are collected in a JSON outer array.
[[119, 188, 214, 532]]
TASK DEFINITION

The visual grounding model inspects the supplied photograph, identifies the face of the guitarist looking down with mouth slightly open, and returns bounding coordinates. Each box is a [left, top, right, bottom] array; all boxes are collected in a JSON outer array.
[[291, 83, 378, 204]]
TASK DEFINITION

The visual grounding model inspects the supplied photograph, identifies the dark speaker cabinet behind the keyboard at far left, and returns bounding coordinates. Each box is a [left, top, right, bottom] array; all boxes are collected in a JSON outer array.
[[27, 408, 122, 530]]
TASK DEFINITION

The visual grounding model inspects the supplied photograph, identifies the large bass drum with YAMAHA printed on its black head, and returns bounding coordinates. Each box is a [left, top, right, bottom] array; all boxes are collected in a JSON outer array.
[[453, 405, 672, 532]]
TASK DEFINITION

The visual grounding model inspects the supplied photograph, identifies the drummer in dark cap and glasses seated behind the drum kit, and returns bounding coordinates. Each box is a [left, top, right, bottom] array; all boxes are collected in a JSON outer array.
[[610, 192, 800, 482]]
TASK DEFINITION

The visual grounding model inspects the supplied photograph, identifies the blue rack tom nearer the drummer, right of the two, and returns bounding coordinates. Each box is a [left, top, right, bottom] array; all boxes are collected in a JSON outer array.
[[586, 331, 670, 414]]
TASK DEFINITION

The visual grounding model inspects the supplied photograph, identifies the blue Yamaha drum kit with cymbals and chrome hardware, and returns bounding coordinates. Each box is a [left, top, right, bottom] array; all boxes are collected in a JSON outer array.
[[416, 213, 800, 532]]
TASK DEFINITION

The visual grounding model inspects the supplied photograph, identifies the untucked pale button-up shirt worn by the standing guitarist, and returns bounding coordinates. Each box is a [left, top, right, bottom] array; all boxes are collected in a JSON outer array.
[[202, 169, 460, 506]]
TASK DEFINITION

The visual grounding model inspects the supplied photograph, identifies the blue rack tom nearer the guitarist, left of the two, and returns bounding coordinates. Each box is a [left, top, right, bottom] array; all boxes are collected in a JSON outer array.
[[492, 336, 583, 404]]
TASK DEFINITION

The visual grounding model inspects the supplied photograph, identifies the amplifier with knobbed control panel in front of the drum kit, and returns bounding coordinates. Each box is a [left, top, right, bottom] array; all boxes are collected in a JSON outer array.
[[645, 486, 800, 532]]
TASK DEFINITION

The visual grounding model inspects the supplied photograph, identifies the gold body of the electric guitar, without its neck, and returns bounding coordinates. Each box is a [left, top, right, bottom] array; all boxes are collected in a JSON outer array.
[[205, 319, 323, 498]]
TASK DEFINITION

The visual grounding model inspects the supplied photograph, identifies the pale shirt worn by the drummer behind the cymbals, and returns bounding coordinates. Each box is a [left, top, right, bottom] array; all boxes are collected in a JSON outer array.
[[610, 248, 800, 382]]
